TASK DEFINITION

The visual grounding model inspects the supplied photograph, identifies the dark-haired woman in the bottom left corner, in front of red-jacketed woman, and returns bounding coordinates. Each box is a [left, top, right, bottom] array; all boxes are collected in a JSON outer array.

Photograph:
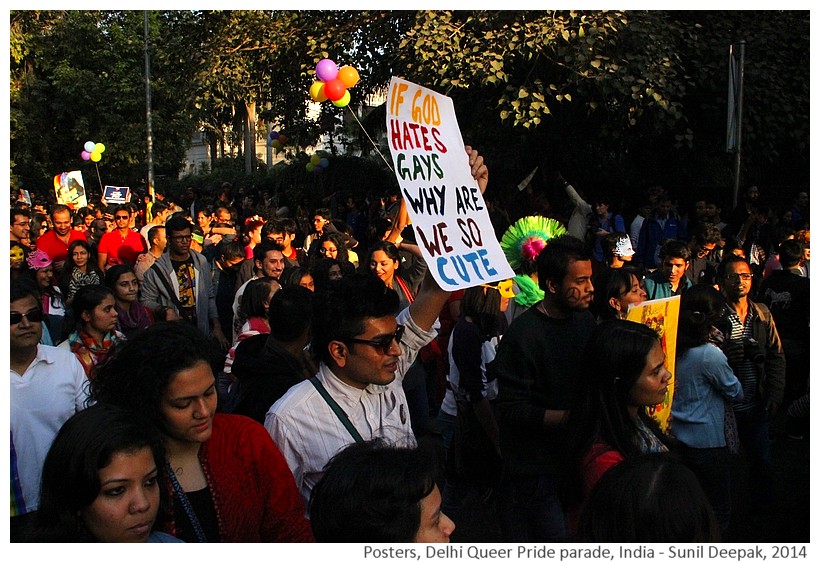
[[26, 404, 180, 543]]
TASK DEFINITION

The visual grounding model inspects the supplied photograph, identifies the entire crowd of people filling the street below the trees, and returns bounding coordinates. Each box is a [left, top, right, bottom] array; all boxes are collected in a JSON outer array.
[[10, 152, 810, 543]]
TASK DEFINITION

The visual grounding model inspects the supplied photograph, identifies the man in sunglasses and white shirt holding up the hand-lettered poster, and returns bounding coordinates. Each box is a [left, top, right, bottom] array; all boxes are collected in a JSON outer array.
[[265, 147, 488, 506]]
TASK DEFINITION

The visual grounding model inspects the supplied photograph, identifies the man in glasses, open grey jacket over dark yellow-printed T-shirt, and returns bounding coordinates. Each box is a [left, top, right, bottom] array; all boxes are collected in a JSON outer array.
[[140, 215, 228, 351]]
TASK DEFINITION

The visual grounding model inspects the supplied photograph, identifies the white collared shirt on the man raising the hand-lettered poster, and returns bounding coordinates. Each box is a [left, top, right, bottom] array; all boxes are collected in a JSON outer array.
[[265, 309, 436, 506]]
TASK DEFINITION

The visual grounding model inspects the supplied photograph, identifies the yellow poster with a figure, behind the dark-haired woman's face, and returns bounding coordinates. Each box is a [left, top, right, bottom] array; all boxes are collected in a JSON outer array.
[[626, 295, 680, 432]]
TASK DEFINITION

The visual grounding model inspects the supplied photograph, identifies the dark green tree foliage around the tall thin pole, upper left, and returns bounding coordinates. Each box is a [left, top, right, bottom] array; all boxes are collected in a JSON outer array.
[[11, 11, 195, 196]]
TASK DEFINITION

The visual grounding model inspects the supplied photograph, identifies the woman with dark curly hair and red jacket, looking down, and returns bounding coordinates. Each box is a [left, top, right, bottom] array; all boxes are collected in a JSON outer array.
[[91, 321, 313, 542]]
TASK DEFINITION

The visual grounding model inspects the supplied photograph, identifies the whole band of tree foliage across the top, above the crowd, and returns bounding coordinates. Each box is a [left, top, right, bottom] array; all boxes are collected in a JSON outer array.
[[10, 10, 809, 204]]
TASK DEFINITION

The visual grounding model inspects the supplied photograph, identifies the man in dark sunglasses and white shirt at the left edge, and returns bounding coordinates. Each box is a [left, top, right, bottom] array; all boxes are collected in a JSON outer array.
[[9, 278, 88, 541]]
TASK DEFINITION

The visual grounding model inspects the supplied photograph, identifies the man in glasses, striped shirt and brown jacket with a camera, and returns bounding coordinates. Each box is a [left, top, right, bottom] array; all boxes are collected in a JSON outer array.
[[718, 255, 786, 511]]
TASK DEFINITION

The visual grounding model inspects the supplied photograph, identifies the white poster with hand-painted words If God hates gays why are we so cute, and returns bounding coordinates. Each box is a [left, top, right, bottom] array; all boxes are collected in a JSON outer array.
[[387, 76, 515, 291]]
